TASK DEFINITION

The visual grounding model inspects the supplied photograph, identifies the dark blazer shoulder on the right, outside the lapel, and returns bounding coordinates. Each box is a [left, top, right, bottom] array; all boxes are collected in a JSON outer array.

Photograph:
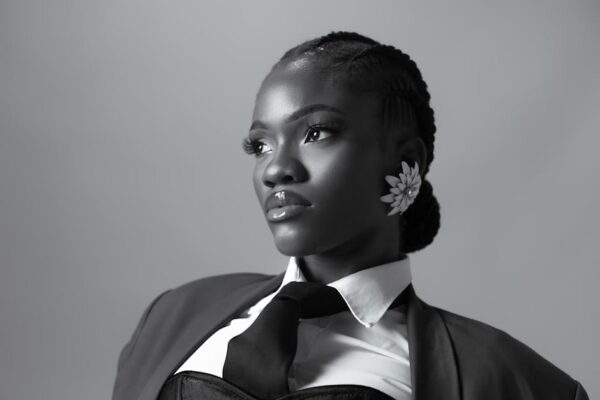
[[437, 308, 586, 399]]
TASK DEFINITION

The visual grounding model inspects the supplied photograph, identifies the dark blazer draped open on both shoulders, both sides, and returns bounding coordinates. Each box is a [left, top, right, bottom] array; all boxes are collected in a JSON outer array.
[[113, 273, 588, 400]]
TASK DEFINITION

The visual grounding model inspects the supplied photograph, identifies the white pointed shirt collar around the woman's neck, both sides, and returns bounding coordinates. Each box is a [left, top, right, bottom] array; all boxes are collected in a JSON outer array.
[[281, 256, 412, 328]]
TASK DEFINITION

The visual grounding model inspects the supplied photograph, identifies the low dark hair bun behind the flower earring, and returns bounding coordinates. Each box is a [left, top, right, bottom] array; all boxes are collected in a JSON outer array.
[[402, 179, 440, 253]]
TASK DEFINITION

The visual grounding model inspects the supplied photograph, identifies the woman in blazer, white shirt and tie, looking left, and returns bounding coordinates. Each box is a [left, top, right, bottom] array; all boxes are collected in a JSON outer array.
[[113, 32, 587, 400]]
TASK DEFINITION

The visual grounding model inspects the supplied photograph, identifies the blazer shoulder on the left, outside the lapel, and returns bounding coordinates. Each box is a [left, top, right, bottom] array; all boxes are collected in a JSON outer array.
[[113, 273, 277, 400]]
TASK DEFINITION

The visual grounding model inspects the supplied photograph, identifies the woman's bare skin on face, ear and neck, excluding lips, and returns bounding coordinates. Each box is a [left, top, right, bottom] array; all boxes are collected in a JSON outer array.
[[249, 62, 427, 283]]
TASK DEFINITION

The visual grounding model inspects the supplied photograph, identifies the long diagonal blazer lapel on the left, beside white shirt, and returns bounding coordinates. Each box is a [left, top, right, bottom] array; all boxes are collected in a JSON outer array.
[[138, 273, 284, 400]]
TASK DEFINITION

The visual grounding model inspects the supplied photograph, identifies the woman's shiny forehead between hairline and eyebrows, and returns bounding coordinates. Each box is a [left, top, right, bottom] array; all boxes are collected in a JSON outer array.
[[253, 61, 378, 123]]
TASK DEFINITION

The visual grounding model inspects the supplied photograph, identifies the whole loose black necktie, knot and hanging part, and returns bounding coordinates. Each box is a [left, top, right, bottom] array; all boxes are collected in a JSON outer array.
[[223, 282, 348, 399]]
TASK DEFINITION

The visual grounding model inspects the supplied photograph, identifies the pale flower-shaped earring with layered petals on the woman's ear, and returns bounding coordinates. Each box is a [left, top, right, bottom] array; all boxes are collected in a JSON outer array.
[[379, 161, 421, 215]]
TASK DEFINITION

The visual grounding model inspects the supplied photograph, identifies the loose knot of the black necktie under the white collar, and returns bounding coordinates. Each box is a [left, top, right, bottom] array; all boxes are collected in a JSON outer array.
[[273, 282, 348, 318]]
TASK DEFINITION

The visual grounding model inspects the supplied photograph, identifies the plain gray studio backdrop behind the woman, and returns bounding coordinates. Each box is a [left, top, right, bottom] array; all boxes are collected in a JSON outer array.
[[0, 0, 600, 400]]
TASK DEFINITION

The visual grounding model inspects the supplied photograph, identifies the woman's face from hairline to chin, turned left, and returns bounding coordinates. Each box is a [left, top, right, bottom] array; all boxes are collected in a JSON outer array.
[[249, 64, 390, 256]]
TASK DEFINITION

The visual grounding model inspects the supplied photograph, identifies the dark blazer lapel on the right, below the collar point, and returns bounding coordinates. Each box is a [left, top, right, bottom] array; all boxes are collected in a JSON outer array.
[[406, 284, 461, 400]]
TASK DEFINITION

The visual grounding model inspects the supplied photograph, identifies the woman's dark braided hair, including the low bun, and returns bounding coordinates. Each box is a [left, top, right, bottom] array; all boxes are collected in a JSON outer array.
[[273, 31, 440, 253]]
